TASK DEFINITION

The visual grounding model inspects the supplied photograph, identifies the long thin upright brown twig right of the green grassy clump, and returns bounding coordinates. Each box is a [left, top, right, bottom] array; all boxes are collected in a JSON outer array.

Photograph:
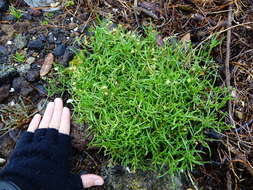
[[225, 4, 235, 126]]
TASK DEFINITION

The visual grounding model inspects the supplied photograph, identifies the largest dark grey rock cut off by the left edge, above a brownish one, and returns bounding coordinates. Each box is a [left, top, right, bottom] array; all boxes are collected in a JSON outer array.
[[0, 65, 18, 86]]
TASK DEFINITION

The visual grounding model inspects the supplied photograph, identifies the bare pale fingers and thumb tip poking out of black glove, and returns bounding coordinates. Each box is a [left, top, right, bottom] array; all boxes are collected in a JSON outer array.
[[27, 98, 104, 188]]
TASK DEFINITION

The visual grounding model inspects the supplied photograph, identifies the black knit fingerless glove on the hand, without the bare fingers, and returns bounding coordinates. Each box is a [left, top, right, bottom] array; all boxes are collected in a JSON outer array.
[[0, 129, 83, 190]]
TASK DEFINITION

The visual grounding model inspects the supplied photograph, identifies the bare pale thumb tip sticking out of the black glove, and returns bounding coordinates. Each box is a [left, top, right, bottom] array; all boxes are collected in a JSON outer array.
[[81, 174, 104, 188]]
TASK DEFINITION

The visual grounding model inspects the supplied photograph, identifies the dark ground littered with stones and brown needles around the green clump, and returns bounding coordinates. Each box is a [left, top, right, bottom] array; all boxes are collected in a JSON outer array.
[[0, 0, 253, 190]]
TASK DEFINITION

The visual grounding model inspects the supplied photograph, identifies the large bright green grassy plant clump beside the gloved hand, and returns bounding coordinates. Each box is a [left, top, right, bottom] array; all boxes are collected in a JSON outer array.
[[48, 23, 228, 173]]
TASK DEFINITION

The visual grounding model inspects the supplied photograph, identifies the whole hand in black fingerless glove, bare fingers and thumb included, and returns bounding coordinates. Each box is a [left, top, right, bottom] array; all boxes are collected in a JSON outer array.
[[0, 98, 104, 190]]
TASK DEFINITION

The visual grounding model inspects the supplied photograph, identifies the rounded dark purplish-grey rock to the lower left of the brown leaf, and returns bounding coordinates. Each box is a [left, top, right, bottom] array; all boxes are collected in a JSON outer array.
[[12, 77, 33, 96]]
